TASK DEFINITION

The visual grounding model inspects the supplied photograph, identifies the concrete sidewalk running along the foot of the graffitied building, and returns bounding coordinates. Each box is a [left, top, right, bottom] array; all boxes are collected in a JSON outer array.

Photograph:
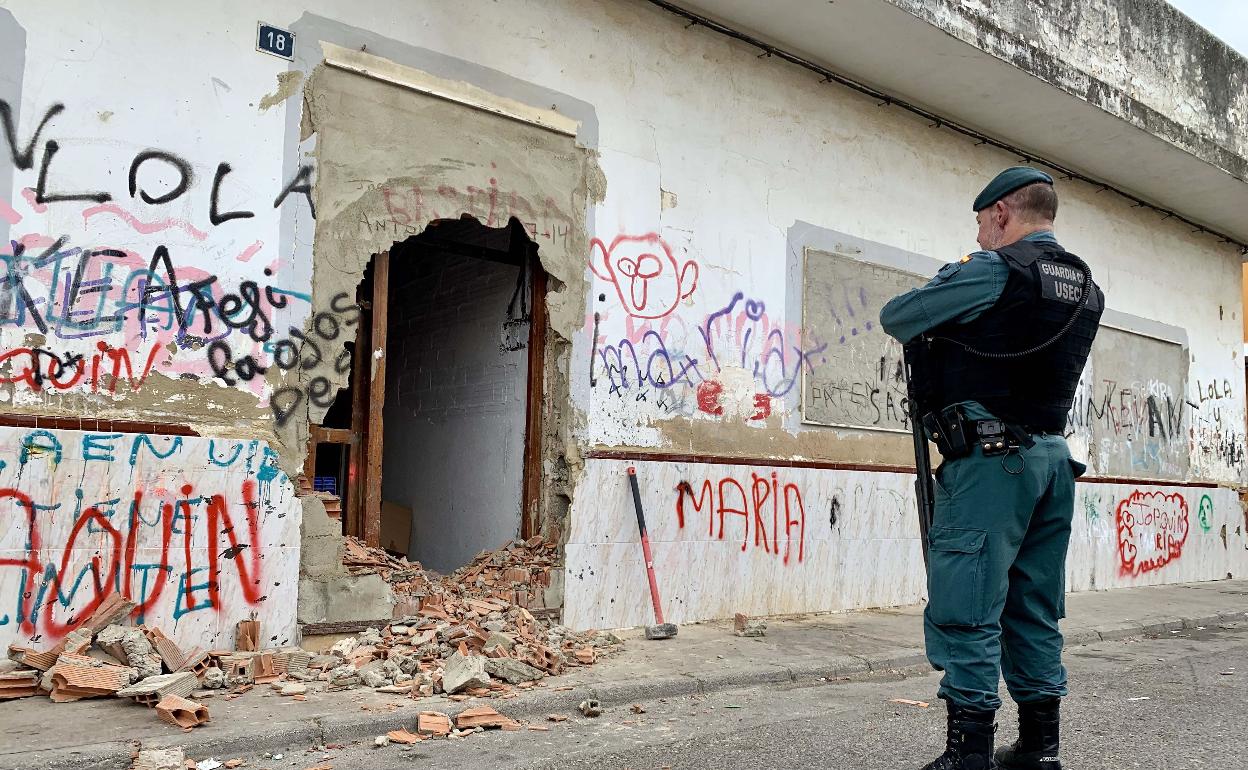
[[0, 580, 1248, 770]]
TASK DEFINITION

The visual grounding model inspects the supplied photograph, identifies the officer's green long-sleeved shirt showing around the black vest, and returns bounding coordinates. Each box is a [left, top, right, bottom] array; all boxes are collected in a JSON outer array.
[[880, 230, 1057, 419]]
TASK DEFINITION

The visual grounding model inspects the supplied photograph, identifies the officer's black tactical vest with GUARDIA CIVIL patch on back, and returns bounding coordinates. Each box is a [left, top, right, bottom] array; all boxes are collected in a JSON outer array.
[[912, 241, 1104, 433]]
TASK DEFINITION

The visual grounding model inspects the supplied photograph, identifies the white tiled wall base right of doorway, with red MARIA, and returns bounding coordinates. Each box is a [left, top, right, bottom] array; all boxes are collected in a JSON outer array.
[[564, 461, 1248, 629]]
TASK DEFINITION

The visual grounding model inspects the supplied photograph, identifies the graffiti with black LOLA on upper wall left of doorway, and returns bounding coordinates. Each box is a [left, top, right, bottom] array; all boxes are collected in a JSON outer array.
[[0, 101, 314, 394]]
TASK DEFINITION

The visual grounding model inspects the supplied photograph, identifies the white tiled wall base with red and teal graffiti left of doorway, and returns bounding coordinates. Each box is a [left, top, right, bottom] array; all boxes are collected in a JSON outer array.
[[0, 428, 300, 649]]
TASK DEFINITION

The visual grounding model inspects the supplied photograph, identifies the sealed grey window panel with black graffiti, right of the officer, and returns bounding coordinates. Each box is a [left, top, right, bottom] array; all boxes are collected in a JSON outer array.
[[1067, 324, 1192, 479]]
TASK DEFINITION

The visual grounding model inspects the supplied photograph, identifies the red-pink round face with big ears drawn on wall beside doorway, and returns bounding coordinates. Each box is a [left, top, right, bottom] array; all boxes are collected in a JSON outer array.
[[589, 232, 698, 318]]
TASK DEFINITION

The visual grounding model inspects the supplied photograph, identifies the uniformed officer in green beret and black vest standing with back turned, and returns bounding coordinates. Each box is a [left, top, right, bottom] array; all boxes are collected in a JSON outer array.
[[880, 167, 1104, 770]]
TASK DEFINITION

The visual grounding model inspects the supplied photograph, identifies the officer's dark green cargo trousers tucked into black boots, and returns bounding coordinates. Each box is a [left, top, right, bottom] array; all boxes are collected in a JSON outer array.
[[924, 434, 1086, 710]]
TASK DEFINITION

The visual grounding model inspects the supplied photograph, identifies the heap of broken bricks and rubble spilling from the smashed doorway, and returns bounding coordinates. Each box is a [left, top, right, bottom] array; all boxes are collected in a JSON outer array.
[[0, 538, 622, 728]]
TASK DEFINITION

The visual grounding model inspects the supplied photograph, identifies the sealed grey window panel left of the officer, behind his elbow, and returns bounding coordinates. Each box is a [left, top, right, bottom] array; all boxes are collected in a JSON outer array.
[[801, 248, 927, 432]]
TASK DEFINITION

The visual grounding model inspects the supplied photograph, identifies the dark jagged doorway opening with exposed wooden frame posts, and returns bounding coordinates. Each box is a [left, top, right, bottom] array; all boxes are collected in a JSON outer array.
[[318, 216, 545, 573]]
